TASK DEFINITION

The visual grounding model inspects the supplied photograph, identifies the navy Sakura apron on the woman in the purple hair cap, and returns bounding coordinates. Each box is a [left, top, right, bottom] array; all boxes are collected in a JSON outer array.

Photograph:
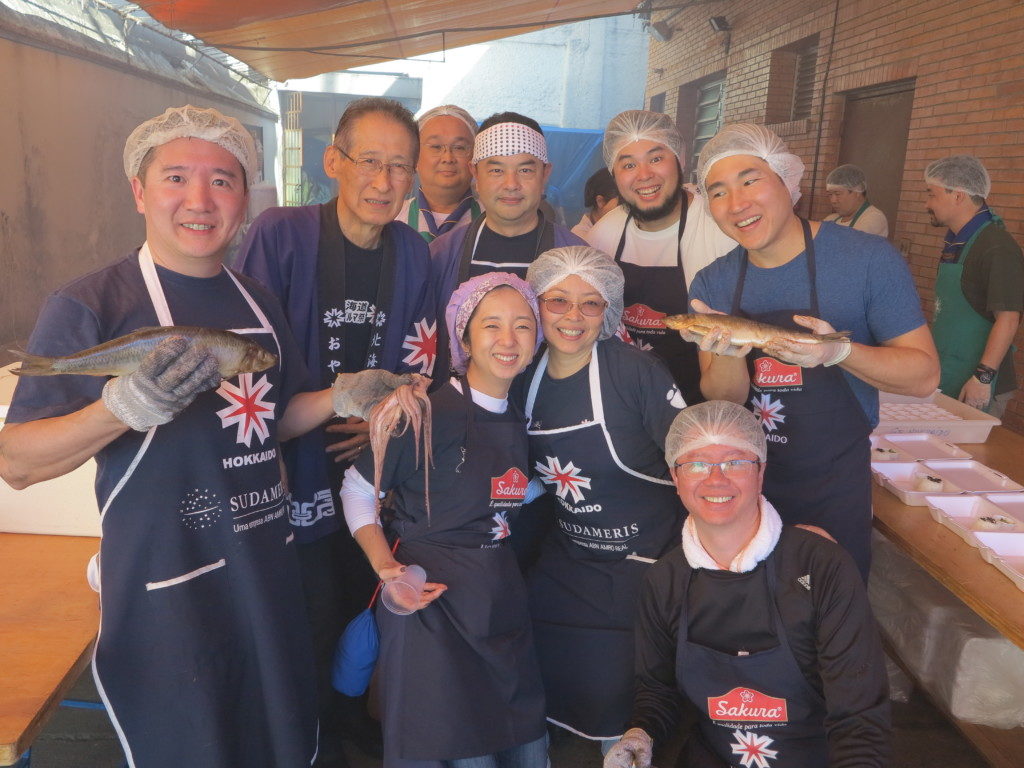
[[377, 379, 545, 768]]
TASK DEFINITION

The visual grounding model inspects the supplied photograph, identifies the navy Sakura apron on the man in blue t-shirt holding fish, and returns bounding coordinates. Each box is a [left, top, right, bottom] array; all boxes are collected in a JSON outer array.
[[730, 220, 871, 581]]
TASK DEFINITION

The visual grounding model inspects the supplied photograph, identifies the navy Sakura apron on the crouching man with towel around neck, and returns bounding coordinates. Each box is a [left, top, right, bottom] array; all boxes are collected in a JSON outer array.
[[676, 552, 828, 768]]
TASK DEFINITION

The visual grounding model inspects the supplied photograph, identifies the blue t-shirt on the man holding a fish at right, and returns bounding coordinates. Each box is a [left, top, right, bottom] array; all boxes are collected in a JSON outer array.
[[690, 221, 925, 427]]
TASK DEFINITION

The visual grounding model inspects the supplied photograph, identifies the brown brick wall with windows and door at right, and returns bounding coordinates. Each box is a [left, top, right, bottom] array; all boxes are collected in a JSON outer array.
[[647, 0, 1024, 432]]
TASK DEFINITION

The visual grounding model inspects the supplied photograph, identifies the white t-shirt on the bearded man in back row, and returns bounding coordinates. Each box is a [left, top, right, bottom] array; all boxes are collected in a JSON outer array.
[[586, 195, 737, 288]]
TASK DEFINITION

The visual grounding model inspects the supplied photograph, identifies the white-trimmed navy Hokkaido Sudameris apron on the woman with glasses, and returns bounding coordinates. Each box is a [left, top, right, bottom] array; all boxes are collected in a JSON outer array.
[[526, 348, 683, 739]]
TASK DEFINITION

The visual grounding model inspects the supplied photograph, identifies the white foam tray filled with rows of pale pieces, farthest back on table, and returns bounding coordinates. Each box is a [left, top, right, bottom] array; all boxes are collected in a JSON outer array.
[[874, 390, 1002, 442]]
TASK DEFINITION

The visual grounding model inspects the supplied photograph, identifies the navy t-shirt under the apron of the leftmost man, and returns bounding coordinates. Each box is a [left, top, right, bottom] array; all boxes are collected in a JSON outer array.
[[7, 251, 313, 507]]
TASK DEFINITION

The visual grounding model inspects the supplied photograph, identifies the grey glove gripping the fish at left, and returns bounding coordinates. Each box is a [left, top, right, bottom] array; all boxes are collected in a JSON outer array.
[[103, 336, 221, 432]]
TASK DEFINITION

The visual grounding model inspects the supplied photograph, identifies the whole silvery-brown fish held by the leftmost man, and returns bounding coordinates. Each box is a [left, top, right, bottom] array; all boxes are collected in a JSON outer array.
[[8, 326, 278, 379]]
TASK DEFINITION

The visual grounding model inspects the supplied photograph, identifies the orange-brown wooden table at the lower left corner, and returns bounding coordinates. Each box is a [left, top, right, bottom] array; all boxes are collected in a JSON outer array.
[[0, 534, 99, 765]]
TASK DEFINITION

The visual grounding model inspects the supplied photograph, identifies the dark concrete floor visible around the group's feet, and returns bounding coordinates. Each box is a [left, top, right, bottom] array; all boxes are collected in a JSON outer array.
[[19, 671, 987, 768]]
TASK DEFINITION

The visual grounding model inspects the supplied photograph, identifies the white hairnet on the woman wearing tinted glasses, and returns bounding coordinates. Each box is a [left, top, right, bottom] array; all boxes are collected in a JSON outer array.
[[526, 246, 626, 339]]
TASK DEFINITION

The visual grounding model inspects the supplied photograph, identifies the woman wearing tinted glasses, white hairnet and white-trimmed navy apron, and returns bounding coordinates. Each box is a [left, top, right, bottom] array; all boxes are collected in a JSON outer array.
[[517, 246, 684, 753]]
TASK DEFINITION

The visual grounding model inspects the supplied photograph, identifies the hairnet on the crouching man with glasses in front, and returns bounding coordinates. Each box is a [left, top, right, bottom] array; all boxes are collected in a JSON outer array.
[[665, 400, 768, 467]]
